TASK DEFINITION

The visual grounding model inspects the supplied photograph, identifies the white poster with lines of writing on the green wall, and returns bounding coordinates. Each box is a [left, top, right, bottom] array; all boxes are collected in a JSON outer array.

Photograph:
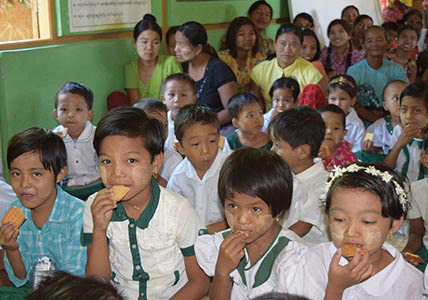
[[68, 0, 151, 32]]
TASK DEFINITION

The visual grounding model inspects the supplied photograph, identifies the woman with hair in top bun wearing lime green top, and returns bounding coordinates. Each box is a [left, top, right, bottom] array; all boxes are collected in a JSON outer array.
[[125, 14, 181, 105]]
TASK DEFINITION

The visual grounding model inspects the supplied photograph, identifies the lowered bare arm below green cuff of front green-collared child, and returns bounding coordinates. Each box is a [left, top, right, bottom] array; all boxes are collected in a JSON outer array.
[[171, 255, 210, 300]]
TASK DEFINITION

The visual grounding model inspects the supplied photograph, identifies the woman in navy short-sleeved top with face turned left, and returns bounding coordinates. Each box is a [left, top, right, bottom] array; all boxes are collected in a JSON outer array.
[[175, 21, 237, 134]]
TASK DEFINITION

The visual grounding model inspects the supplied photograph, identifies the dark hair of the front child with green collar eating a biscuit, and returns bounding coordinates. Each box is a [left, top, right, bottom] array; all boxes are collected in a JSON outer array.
[[94, 107, 165, 162]]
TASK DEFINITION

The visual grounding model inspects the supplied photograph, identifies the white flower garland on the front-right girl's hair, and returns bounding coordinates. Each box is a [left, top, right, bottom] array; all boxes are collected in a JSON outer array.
[[320, 164, 410, 212]]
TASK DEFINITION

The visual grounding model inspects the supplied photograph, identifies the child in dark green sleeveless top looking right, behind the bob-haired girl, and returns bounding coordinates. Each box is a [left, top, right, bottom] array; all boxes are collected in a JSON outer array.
[[226, 92, 272, 150]]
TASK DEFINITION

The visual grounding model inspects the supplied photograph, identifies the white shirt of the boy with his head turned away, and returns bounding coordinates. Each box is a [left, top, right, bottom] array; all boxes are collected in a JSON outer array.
[[282, 160, 330, 245]]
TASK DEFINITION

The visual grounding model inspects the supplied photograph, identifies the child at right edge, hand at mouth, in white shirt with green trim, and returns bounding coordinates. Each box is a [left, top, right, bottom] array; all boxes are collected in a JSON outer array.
[[384, 81, 428, 182]]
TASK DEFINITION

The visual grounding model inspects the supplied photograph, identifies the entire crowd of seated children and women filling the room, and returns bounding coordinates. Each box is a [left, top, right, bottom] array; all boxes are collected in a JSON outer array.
[[0, 1, 428, 300]]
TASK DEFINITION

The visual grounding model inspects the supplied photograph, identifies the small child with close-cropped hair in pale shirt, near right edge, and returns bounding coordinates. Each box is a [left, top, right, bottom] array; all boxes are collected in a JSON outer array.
[[363, 80, 407, 154]]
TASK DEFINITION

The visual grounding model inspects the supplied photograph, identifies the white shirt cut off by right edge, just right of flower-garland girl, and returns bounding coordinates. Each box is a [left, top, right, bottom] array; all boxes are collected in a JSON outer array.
[[407, 178, 428, 249]]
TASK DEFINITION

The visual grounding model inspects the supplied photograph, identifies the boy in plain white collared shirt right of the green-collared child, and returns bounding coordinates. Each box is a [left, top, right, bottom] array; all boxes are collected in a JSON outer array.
[[167, 104, 227, 233]]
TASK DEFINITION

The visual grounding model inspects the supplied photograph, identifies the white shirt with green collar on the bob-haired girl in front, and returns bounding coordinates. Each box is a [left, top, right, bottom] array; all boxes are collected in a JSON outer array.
[[195, 228, 307, 300]]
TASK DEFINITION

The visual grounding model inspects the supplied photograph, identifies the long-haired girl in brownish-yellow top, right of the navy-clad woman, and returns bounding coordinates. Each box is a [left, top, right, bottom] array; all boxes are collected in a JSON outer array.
[[219, 17, 265, 92]]
